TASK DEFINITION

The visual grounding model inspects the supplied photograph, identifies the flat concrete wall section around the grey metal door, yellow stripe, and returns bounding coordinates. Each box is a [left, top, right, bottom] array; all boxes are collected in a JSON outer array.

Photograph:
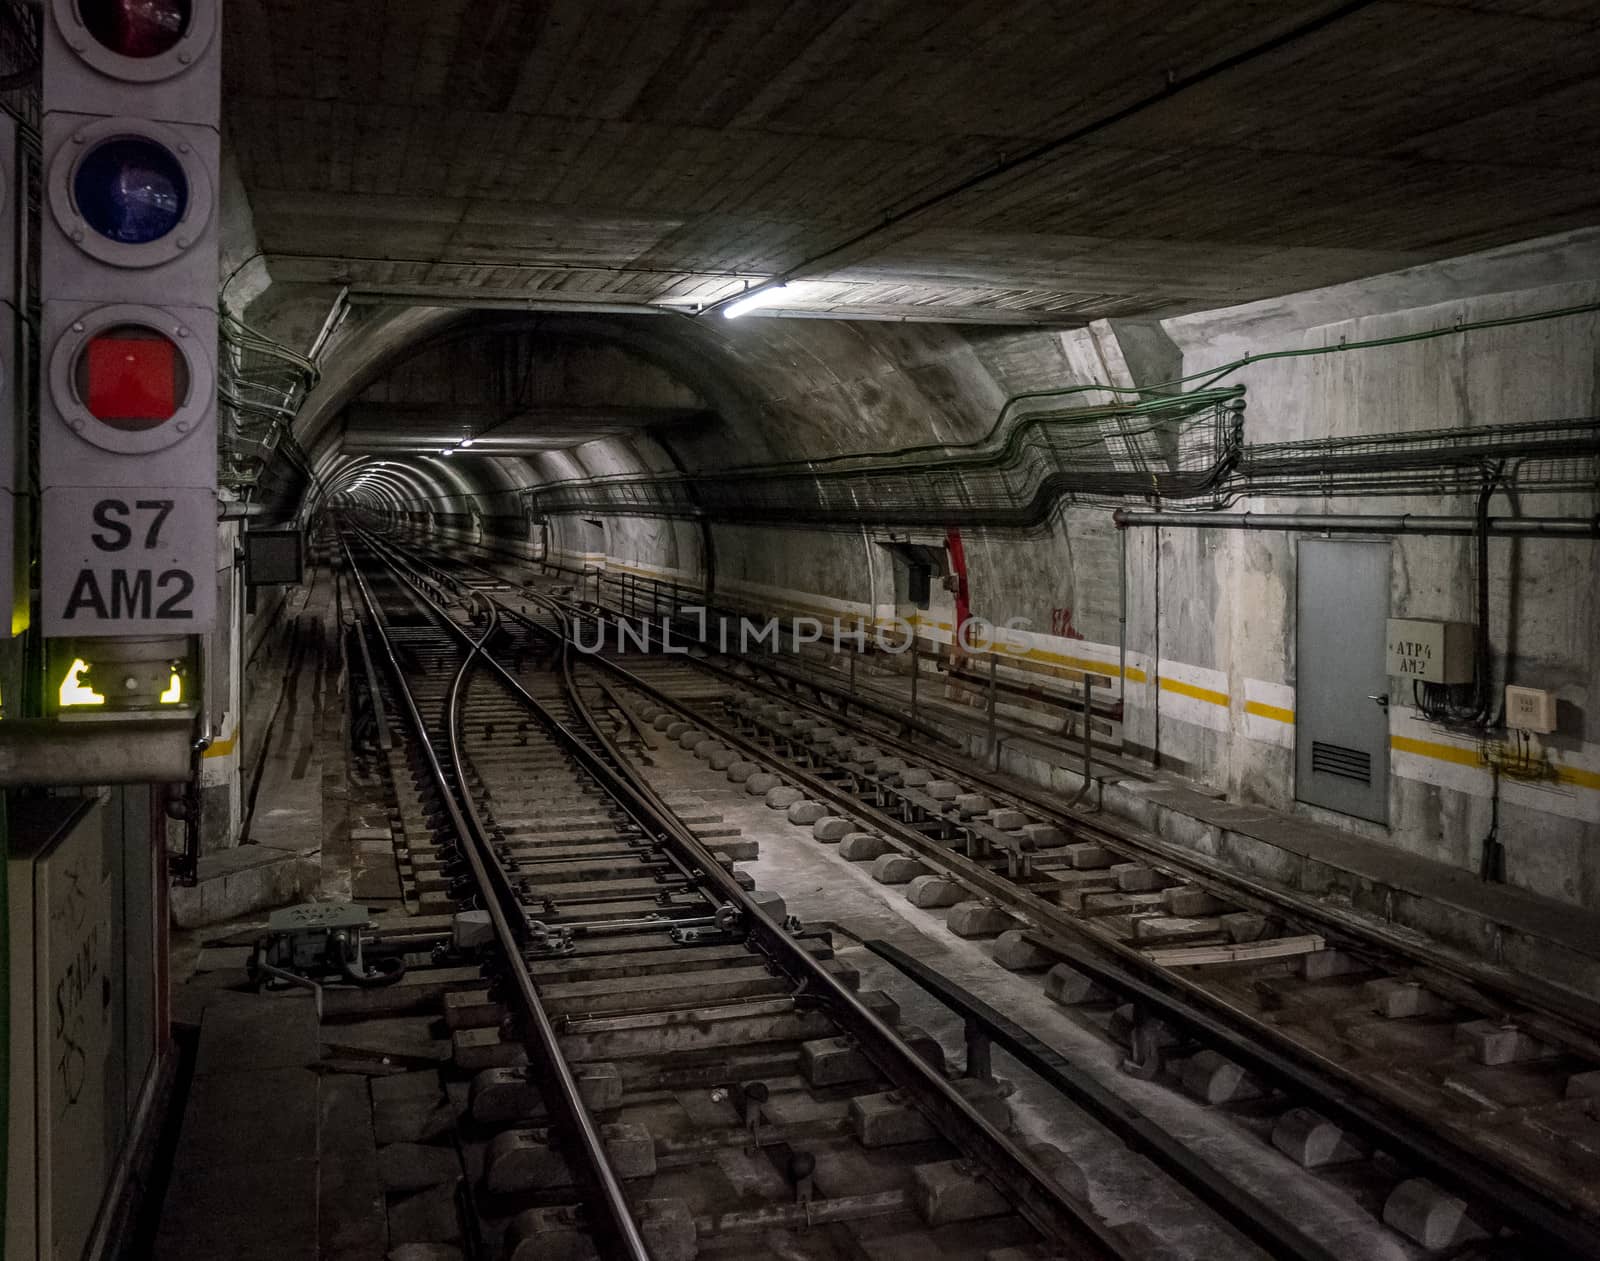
[[1128, 283, 1600, 907]]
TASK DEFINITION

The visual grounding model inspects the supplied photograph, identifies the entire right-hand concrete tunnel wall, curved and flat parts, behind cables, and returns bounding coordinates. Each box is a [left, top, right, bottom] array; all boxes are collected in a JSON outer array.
[[300, 241, 1600, 906]]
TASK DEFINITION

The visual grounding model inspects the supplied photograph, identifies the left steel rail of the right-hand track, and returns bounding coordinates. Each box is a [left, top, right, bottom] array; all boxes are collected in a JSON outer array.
[[489, 585, 1600, 1261]]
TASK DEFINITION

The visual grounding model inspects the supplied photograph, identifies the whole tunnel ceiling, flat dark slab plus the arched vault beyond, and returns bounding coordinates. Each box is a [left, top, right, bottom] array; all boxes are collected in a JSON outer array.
[[224, 0, 1600, 521]]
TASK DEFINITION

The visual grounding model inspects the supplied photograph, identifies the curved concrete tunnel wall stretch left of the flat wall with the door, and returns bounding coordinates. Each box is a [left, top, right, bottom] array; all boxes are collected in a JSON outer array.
[[377, 320, 1118, 659]]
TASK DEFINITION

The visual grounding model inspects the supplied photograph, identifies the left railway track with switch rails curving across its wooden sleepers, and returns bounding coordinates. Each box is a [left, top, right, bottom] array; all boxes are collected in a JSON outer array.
[[347, 539, 1149, 1261]]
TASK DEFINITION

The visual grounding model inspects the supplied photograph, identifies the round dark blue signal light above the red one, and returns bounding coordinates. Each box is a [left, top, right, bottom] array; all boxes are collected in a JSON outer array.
[[72, 136, 189, 245]]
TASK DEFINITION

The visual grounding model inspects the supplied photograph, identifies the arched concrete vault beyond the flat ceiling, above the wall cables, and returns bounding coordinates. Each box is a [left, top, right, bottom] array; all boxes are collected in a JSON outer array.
[[301, 312, 1113, 518]]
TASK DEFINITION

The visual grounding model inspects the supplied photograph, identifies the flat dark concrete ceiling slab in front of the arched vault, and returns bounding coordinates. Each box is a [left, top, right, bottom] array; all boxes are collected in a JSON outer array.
[[226, 0, 1600, 323]]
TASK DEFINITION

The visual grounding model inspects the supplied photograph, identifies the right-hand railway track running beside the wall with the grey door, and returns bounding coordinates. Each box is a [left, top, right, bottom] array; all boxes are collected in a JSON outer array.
[[368, 528, 1600, 1258]]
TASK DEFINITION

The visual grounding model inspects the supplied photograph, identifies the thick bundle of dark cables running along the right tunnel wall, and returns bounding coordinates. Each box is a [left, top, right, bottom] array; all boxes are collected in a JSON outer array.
[[526, 302, 1600, 534]]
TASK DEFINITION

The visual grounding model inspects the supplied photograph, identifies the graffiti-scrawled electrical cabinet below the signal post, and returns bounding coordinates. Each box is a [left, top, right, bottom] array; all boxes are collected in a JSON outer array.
[[0, 786, 166, 1261]]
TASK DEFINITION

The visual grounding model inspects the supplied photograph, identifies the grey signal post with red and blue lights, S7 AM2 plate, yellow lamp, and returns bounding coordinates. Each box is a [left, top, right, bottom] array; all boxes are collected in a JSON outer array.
[[38, 0, 221, 717]]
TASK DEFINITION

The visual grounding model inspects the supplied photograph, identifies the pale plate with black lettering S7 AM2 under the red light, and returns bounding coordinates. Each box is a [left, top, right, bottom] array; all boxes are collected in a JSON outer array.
[[40, 486, 216, 635]]
